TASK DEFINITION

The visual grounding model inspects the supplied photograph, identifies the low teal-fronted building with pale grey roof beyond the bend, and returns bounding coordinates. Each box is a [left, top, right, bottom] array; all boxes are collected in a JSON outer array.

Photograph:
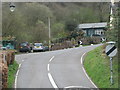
[[78, 22, 107, 37]]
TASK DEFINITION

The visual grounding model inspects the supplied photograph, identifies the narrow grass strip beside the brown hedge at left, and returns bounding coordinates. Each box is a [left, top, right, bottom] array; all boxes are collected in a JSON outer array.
[[8, 61, 19, 88]]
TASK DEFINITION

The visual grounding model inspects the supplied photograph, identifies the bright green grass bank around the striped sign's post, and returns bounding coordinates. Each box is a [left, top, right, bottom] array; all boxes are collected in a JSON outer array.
[[84, 46, 118, 88]]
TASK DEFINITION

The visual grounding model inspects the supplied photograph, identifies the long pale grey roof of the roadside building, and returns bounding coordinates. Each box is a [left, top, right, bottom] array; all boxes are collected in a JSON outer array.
[[78, 22, 107, 29]]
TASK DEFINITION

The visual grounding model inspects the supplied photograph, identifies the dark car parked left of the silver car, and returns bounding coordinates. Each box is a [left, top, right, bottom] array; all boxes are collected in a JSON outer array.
[[19, 42, 31, 52]]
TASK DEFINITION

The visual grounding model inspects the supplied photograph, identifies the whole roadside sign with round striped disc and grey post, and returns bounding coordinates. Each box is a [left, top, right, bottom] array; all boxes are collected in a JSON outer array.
[[105, 42, 117, 85]]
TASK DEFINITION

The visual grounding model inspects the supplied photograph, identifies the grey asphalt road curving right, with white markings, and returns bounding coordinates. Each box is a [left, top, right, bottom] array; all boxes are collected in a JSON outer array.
[[15, 44, 100, 88]]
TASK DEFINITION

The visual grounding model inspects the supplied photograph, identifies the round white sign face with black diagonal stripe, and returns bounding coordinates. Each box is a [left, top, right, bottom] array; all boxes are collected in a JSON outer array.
[[105, 45, 117, 57]]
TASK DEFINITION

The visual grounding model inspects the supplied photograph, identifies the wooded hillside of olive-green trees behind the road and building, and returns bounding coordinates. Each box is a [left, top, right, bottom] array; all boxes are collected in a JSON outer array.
[[2, 2, 109, 43]]
